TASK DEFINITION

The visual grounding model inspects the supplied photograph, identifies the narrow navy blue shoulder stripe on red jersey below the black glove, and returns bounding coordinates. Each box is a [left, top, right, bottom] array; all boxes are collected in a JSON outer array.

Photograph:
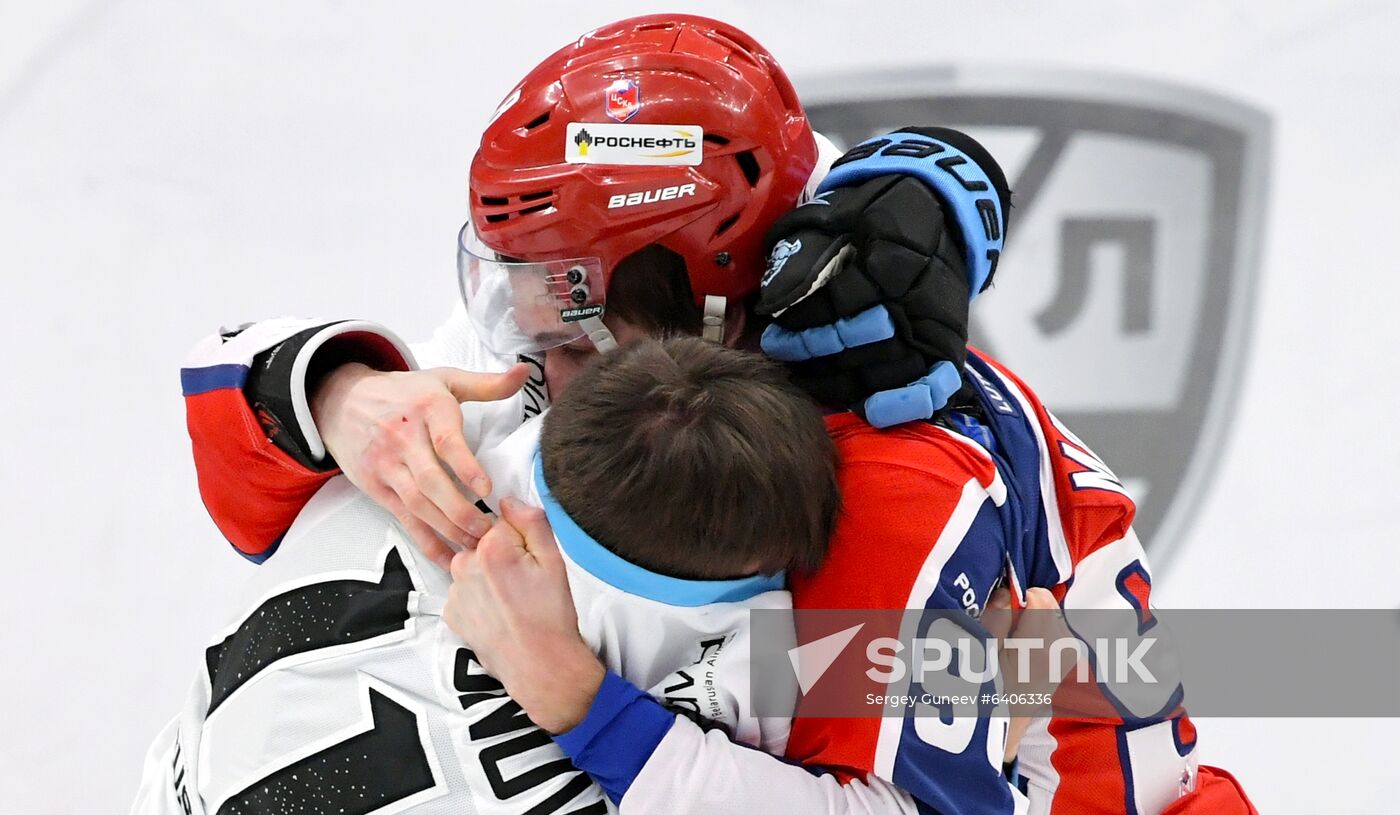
[[966, 354, 1060, 588]]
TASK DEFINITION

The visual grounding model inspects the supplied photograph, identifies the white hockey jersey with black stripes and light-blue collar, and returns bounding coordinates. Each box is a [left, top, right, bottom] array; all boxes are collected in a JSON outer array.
[[133, 420, 791, 815]]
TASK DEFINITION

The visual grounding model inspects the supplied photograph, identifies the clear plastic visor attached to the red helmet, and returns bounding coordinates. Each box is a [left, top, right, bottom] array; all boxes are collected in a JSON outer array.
[[456, 223, 606, 356]]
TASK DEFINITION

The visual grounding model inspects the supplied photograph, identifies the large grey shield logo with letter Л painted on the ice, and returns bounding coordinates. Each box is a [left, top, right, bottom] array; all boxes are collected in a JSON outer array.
[[801, 67, 1270, 567]]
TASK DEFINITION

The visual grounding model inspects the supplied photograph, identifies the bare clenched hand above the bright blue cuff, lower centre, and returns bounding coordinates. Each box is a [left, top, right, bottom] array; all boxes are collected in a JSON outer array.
[[442, 499, 605, 734]]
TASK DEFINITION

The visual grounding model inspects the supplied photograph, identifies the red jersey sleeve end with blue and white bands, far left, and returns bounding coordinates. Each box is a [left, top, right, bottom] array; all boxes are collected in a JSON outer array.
[[181, 319, 414, 563]]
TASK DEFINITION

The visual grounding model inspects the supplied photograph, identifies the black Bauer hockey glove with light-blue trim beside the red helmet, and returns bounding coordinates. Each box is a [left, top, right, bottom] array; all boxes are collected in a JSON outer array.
[[757, 127, 1011, 427]]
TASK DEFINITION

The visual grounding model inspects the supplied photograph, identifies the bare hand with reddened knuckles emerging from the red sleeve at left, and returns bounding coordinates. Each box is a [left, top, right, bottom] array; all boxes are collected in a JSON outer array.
[[311, 363, 529, 569]]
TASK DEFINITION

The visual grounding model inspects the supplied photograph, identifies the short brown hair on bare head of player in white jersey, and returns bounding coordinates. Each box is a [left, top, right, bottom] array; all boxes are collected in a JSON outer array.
[[540, 337, 840, 580]]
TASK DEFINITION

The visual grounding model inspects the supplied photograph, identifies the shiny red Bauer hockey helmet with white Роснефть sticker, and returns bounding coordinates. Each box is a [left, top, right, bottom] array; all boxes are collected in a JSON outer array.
[[462, 15, 816, 349]]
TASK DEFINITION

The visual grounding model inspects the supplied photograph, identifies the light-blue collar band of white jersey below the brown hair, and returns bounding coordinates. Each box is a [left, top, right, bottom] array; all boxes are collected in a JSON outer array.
[[535, 454, 787, 606]]
